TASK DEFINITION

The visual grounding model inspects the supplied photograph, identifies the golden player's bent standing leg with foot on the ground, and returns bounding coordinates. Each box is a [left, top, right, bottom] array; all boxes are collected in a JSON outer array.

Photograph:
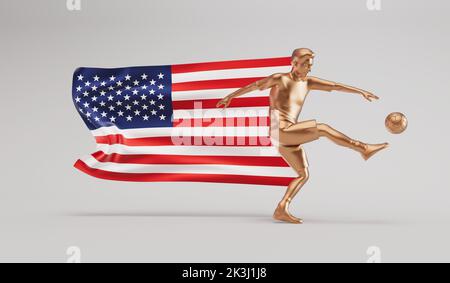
[[274, 146, 309, 224]]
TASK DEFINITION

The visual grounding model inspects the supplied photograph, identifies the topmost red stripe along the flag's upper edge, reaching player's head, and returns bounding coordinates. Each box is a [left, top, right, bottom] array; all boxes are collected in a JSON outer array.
[[172, 57, 291, 74]]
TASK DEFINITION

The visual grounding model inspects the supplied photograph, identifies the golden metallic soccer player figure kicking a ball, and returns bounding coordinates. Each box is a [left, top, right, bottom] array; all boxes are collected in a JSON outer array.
[[217, 48, 388, 224]]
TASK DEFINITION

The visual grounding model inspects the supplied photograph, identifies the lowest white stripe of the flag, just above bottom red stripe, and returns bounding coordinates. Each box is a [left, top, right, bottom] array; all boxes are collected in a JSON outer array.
[[81, 156, 295, 177]]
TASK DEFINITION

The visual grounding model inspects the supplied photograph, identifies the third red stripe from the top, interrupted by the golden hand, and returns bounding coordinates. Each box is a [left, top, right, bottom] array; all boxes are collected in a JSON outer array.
[[172, 96, 270, 110]]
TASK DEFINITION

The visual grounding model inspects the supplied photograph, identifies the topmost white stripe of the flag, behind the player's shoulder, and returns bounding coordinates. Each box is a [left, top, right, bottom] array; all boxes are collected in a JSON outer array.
[[172, 66, 289, 83]]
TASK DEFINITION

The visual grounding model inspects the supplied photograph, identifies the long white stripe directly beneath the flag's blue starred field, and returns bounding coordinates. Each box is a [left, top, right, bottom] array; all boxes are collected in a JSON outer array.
[[92, 126, 269, 139]]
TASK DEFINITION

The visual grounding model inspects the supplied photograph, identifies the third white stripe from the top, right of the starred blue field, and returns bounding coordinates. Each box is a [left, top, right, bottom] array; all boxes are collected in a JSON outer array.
[[173, 106, 269, 119]]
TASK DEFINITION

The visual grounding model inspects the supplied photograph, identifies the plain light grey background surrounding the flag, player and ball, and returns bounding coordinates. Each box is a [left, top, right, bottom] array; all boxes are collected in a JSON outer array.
[[0, 0, 450, 262]]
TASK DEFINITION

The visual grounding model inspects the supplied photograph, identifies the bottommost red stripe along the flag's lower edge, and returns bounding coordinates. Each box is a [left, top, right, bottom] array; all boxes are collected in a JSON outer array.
[[74, 160, 294, 186]]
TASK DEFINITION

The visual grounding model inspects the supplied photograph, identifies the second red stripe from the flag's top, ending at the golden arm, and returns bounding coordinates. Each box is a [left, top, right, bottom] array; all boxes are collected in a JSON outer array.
[[172, 77, 264, 91]]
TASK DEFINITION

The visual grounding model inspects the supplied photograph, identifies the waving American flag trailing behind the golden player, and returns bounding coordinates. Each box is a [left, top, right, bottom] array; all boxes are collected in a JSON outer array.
[[72, 57, 296, 186]]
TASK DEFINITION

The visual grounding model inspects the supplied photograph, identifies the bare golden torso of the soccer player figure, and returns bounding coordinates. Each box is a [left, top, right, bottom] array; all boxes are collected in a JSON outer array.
[[270, 74, 309, 123]]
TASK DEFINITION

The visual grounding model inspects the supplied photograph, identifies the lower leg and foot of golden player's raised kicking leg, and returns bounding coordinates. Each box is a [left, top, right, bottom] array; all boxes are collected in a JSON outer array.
[[317, 124, 389, 160]]
